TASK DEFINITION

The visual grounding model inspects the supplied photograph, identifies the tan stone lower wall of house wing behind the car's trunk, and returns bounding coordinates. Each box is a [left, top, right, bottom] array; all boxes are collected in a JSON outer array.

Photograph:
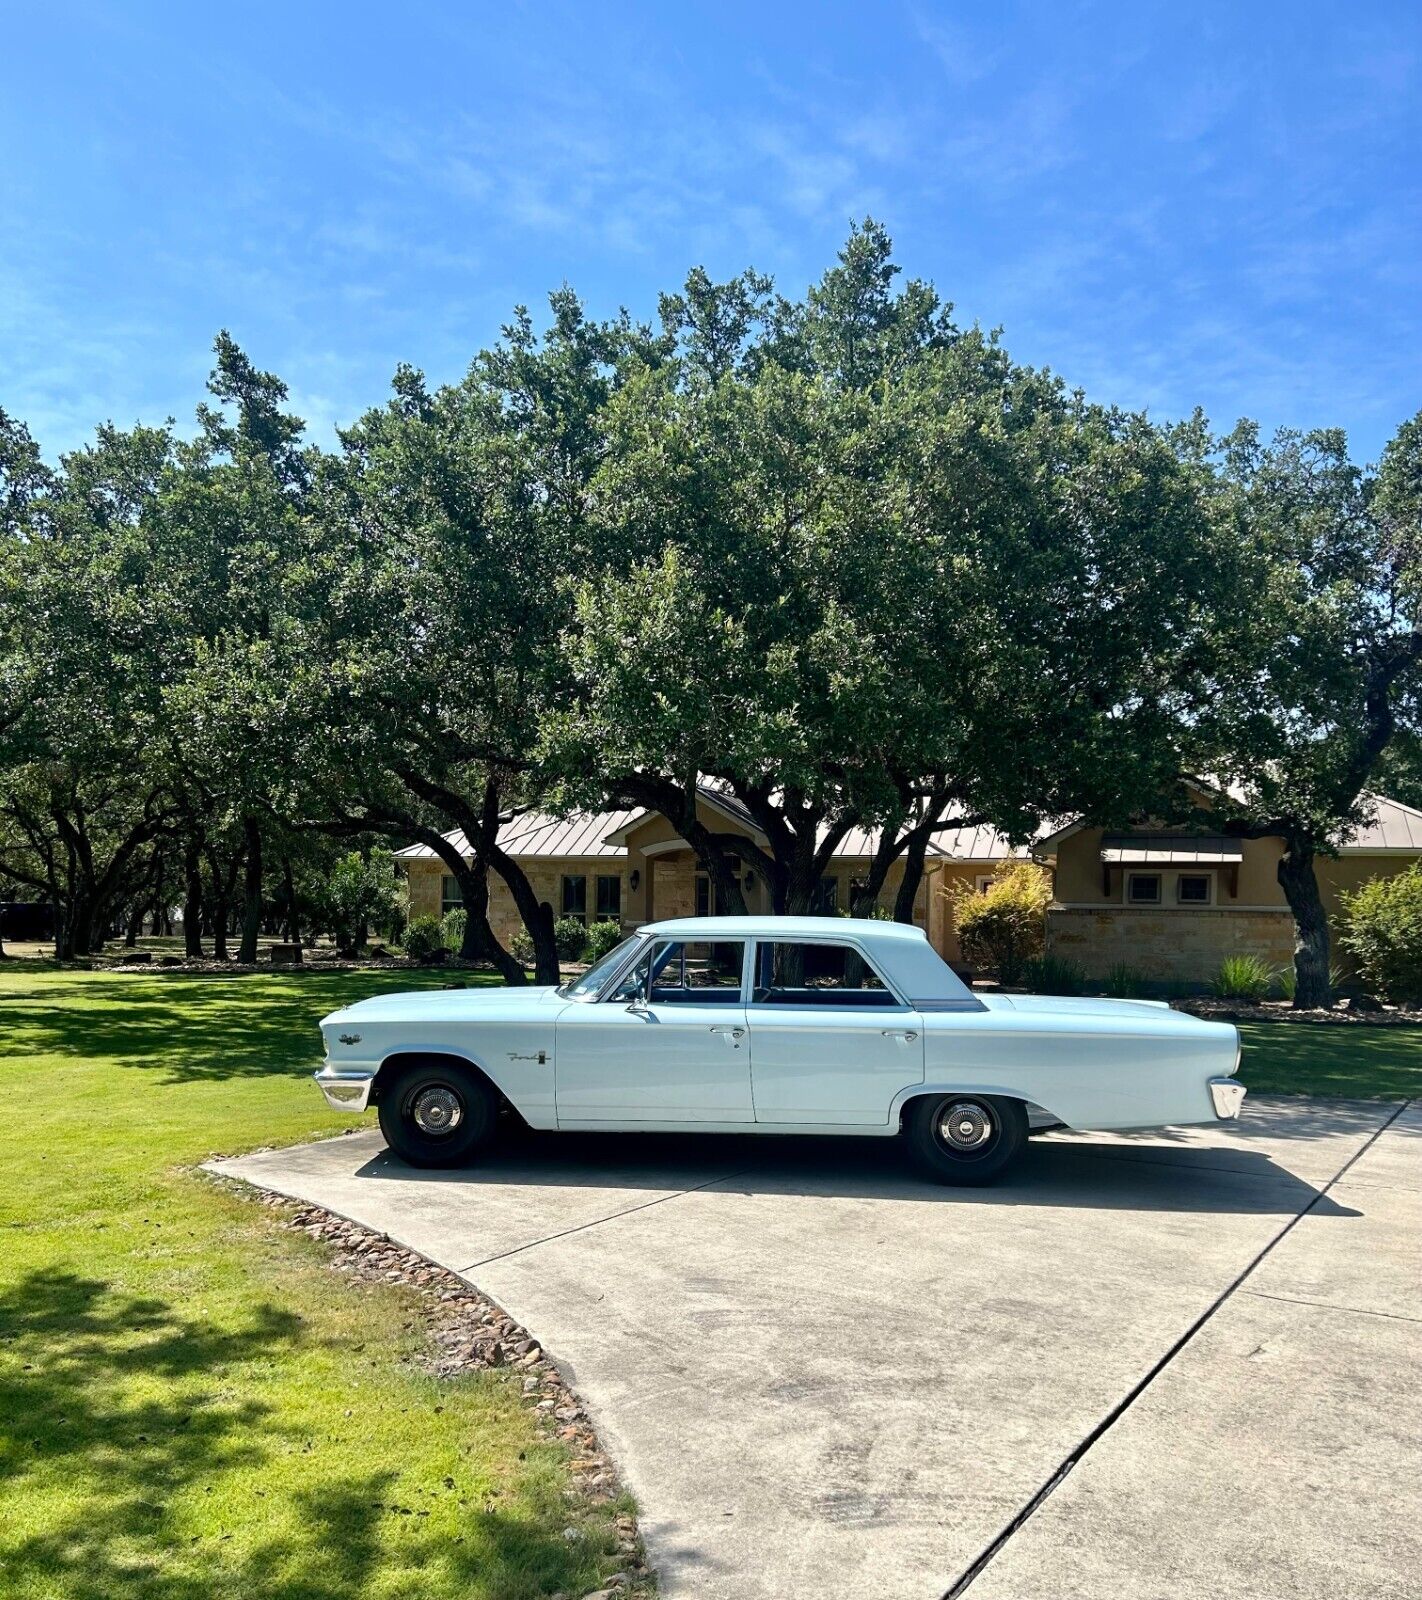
[[1046, 906, 1294, 982]]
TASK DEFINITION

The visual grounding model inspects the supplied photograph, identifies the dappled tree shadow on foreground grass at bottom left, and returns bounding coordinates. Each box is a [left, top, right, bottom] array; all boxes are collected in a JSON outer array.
[[0, 1272, 617, 1600]]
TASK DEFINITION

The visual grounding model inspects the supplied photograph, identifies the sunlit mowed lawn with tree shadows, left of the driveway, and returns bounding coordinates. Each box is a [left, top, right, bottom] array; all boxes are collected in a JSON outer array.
[[0, 962, 633, 1600]]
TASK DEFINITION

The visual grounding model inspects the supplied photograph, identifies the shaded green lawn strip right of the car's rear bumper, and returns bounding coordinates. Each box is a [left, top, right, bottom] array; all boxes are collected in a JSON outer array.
[[1240, 1022, 1422, 1099]]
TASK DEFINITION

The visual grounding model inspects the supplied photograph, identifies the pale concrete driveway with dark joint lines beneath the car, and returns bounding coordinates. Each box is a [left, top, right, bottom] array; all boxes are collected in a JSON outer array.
[[221, 1099, 1422, 1600]]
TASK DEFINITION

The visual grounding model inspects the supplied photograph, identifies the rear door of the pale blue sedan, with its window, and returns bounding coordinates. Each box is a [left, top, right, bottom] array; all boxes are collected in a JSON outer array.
[[745, 939, 923, 1126]]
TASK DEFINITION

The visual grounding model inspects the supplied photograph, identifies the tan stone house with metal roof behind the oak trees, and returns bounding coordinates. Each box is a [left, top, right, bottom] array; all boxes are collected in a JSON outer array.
[[395, 787, 1422, 982]]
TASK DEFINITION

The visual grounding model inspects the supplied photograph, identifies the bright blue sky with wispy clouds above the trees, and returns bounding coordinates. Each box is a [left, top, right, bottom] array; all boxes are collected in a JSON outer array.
[[0, 0, 1422, 459]]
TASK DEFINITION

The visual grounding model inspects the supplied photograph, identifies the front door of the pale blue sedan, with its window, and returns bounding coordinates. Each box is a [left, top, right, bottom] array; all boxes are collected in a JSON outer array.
[[553, 939, 755, 1128]]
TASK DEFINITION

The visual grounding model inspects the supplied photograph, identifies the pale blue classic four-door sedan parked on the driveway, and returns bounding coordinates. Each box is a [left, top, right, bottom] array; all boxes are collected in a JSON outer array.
[[315, 917, 1244, 1184]]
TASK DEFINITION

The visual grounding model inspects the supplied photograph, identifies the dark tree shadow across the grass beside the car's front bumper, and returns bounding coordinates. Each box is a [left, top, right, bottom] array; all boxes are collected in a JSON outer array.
[[0, 970, 481, 1083]]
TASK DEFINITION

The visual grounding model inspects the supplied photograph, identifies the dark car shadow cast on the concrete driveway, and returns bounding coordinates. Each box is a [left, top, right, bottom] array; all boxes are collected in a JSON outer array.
[[355, 1130, 1360, 1218]]
